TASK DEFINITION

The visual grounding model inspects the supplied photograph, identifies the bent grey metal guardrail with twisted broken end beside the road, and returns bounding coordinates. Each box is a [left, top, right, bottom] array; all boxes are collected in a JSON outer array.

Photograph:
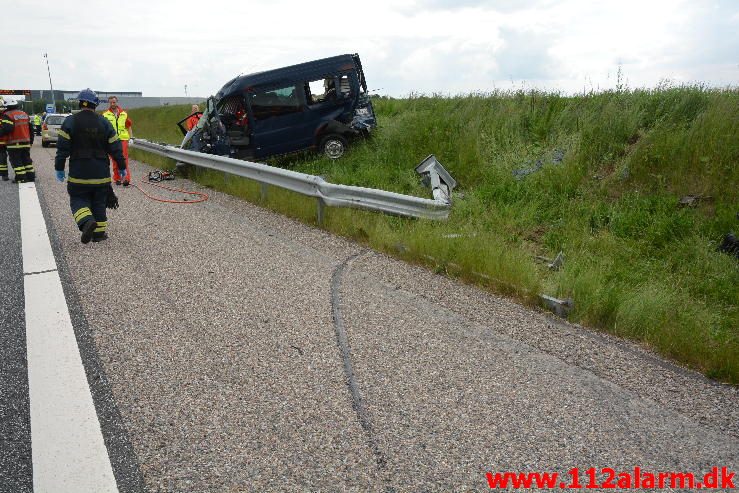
[[130, 139, 457, 223]]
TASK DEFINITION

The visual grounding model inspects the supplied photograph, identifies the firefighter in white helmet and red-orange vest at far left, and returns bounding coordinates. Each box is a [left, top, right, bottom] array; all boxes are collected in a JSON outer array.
[[0, 97, 36, 183]]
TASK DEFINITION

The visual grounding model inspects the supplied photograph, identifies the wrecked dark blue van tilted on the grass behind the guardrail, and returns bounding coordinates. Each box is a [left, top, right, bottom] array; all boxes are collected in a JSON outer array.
[[178, 54, 377, 160]]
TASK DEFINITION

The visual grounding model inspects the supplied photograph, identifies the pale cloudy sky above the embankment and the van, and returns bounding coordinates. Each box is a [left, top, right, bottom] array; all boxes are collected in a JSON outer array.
[[7, 0, 739, 97]]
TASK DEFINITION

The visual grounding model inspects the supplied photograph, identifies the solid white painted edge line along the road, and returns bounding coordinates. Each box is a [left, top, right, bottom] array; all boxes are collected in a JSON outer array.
[[19, 183, 118, 493]]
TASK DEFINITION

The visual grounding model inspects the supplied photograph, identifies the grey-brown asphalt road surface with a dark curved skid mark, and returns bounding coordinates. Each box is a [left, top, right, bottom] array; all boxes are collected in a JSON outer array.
[[0, 143, 739, 493]]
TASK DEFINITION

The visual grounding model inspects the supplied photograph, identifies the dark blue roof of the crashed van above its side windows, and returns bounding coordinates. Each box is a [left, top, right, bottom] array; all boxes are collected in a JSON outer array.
[[216, 54, 367, 99]]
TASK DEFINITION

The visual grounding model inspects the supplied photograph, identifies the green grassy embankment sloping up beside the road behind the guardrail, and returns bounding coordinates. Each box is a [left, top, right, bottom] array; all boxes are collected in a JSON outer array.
[[131, 87, 739, 383]]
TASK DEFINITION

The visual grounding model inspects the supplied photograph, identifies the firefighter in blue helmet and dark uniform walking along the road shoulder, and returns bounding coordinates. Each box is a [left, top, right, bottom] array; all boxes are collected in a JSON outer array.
[[54, 89, 126, 243]]
